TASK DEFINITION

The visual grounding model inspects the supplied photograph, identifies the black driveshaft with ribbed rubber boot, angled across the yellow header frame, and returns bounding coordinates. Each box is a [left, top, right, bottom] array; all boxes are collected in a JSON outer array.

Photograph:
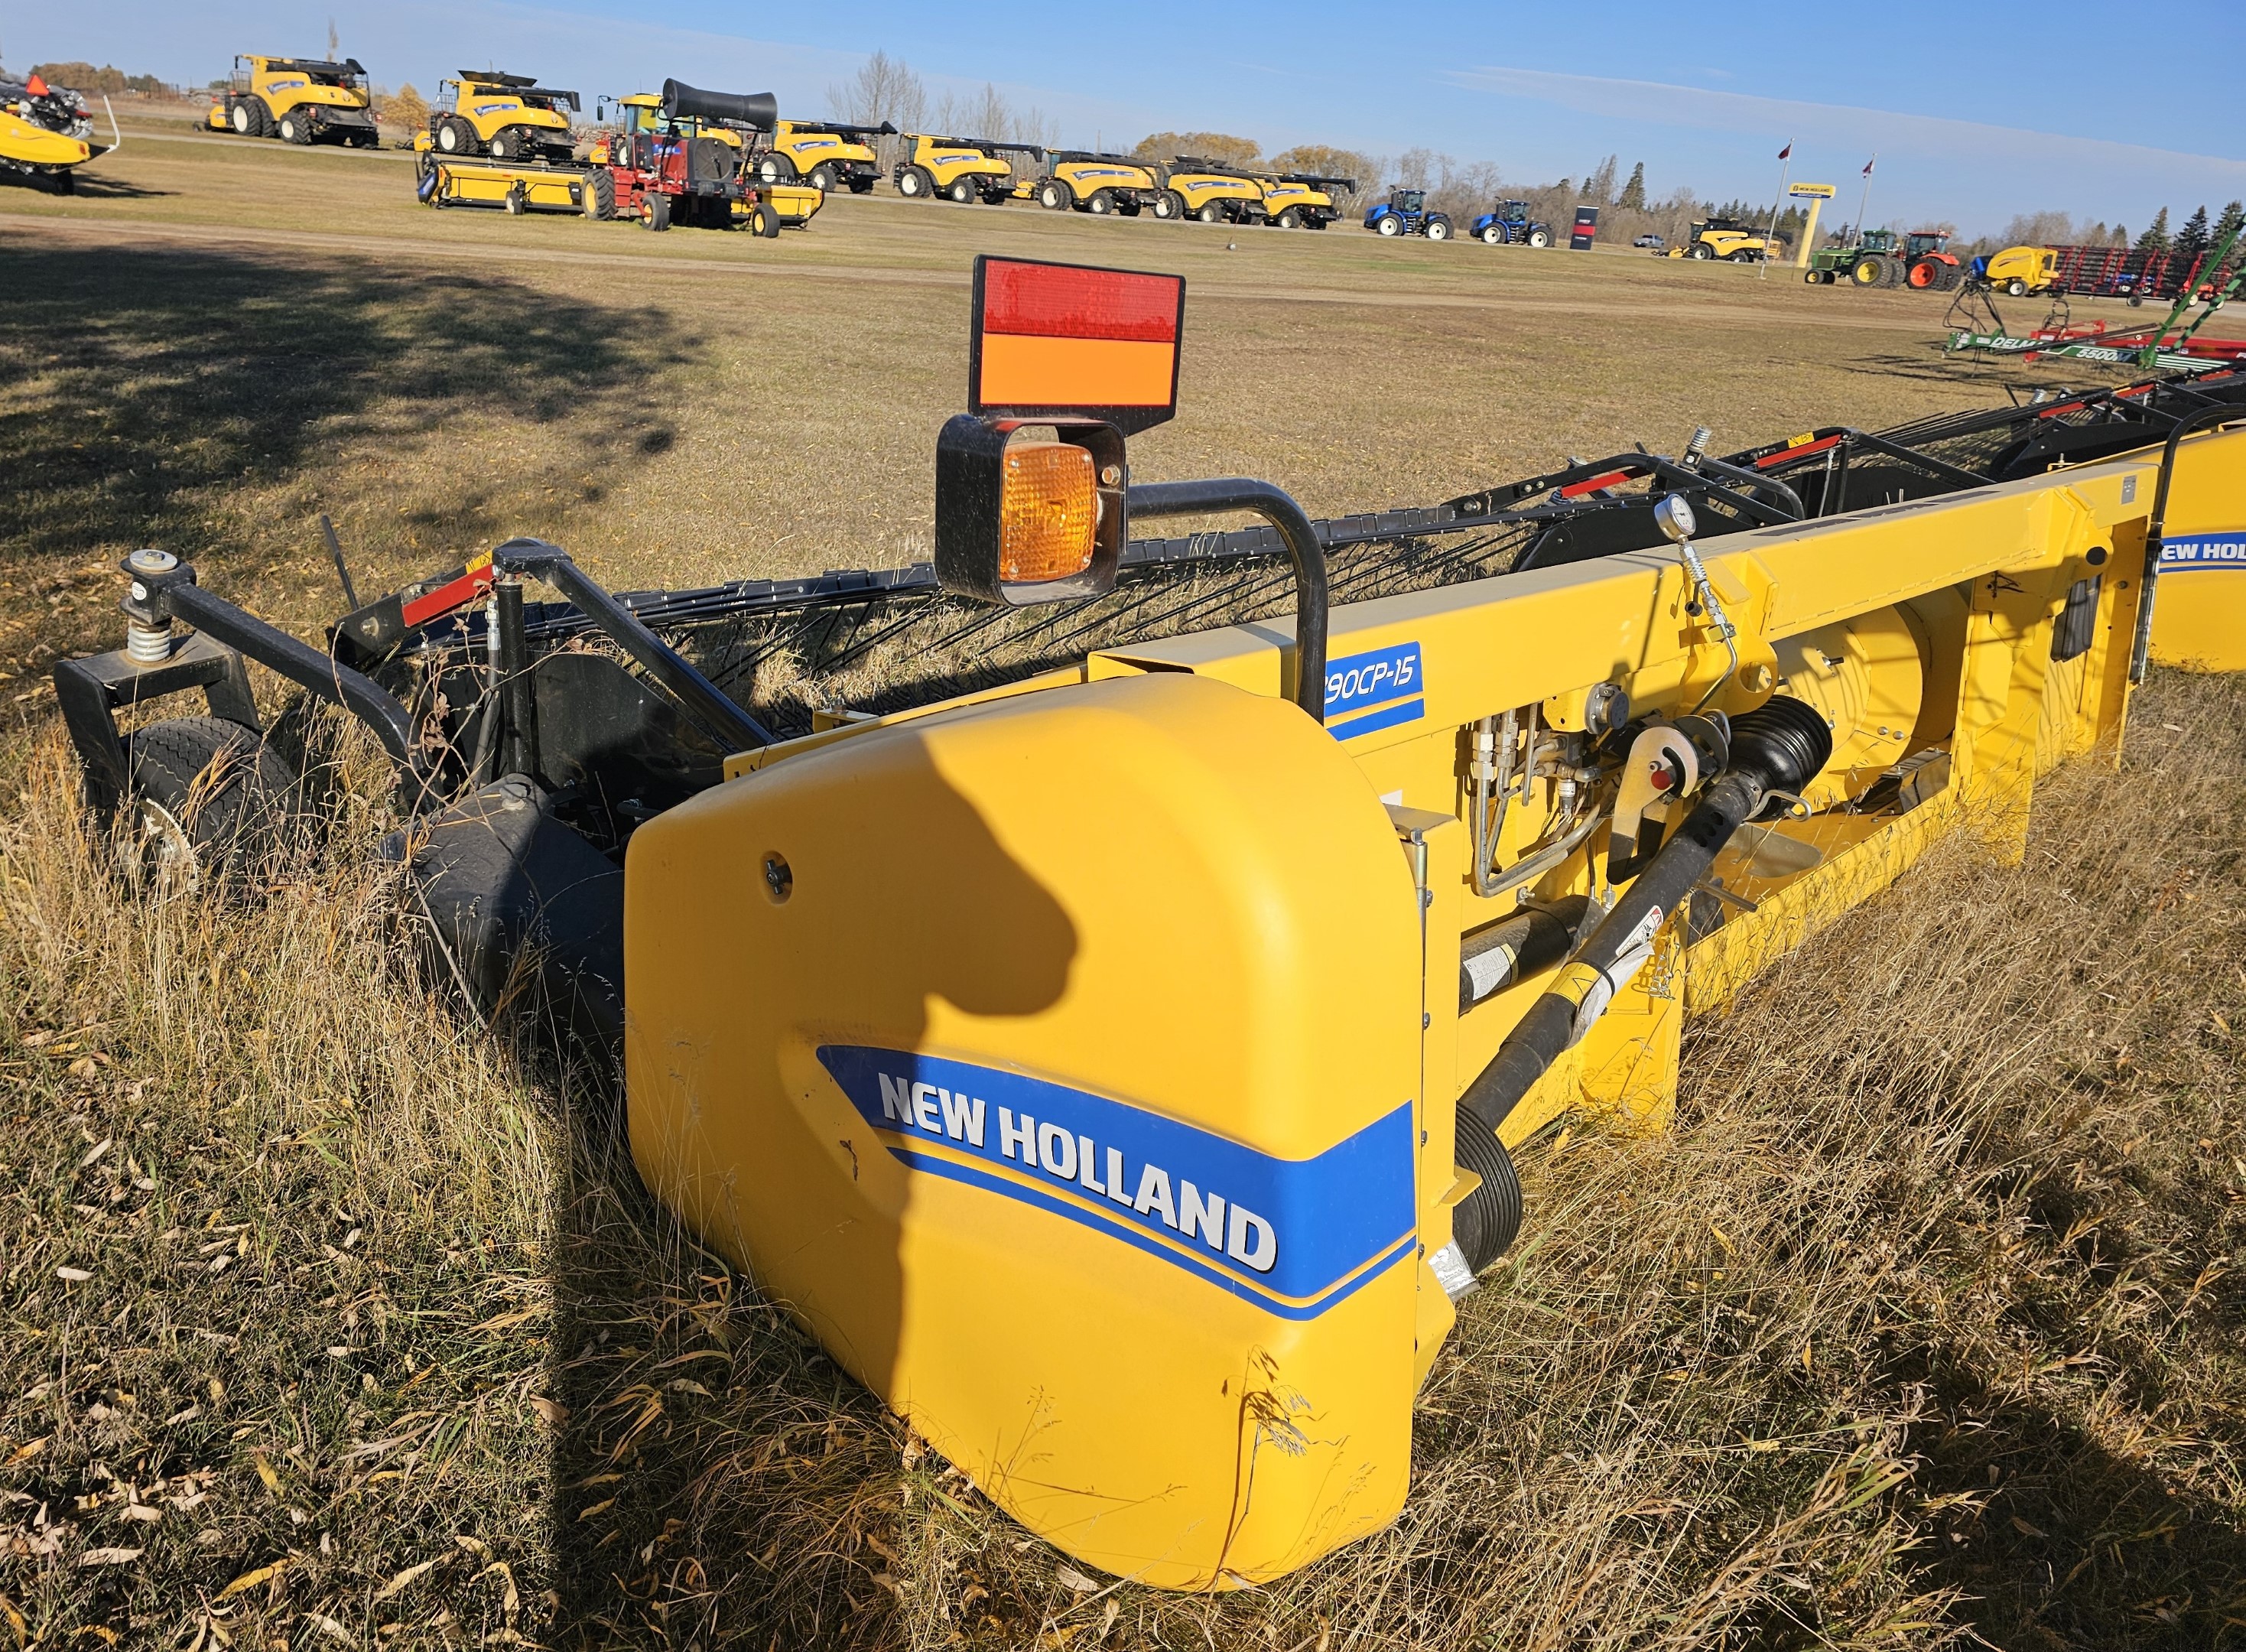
[[1453, 694, 1833, 1272]]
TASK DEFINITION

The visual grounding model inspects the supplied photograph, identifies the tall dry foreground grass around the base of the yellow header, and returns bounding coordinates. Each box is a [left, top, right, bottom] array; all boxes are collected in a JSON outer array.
[[0, 679, 2246, 1647]]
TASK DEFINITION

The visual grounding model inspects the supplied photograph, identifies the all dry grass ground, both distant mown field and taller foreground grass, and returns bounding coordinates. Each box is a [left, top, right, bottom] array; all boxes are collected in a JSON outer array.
[[0, 122, 2246, 1652]]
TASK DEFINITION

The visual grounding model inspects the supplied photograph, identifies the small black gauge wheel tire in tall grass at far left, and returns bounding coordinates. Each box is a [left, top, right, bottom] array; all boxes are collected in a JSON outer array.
[[115, 717, 301, 895]]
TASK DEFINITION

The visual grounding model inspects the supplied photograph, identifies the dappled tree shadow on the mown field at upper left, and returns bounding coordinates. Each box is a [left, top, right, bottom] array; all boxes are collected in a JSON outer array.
[[0, 242, 687, 571]]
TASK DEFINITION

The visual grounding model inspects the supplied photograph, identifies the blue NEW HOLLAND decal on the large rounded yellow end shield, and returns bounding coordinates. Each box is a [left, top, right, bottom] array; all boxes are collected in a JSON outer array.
[[817, 1046, 1417, 1319]]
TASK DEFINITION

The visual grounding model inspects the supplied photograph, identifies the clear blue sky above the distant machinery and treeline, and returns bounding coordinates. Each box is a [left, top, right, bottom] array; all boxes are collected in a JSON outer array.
[[17, 0, 2246, 234]]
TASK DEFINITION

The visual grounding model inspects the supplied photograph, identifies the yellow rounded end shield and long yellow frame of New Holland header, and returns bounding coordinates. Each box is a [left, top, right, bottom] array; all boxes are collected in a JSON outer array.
[[624, 377, 2246, 1589]]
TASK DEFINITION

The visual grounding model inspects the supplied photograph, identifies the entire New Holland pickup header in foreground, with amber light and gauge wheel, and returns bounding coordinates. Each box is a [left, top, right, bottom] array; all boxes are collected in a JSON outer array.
[[56, 259, 2246, 1589]]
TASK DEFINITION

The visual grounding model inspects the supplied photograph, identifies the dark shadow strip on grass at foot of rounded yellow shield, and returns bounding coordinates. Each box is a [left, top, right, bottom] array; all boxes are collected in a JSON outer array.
[[544, 1075, 905, 1647]]
